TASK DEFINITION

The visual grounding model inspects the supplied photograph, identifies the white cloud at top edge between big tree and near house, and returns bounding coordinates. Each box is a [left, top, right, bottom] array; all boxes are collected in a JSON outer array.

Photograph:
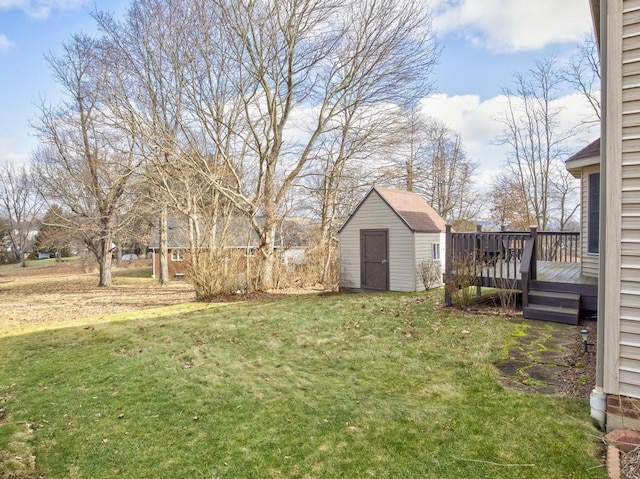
[[432, 0, 592, 52]]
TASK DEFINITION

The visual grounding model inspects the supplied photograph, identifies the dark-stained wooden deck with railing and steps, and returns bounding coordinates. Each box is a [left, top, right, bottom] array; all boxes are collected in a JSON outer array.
[[445, 226, 598, 324]]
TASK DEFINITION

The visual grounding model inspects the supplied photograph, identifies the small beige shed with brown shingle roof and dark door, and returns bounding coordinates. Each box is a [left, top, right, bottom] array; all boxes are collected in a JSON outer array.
[[338, 187, 446, 291]]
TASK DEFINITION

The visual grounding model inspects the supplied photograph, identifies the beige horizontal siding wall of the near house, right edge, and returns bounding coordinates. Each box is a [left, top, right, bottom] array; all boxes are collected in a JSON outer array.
[[601, 0, 640, 398]]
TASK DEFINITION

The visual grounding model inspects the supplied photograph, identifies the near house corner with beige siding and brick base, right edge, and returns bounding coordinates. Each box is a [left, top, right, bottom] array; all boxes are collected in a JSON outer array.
[[590, 0, 640, 430]]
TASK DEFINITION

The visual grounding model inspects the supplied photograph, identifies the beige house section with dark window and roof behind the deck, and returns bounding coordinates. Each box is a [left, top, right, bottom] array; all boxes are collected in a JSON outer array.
[[565, 139, 600, 278]]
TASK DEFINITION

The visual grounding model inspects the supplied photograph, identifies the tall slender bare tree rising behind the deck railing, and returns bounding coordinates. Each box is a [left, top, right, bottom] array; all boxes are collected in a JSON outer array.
[[499, 59, 576, 230]]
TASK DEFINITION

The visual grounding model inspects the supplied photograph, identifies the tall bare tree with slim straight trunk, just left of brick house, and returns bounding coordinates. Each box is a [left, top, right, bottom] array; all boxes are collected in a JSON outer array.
[[95, 0, 189, 284]]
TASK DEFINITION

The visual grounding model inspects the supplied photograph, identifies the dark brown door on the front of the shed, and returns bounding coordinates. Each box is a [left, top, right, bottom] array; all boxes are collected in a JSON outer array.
[[360, 230, 389, 291]]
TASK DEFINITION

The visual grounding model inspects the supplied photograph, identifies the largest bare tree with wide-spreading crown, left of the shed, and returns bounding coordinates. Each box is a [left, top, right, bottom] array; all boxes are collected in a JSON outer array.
[[172, 0, 437, 288]]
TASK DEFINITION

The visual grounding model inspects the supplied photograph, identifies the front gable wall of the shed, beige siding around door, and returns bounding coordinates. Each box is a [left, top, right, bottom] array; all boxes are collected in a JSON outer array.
[[339, 191, 416, 291]]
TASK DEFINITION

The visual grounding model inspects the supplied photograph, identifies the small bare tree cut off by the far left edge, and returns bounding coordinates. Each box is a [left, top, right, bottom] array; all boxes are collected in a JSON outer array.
[[0, 162, 44, 267]]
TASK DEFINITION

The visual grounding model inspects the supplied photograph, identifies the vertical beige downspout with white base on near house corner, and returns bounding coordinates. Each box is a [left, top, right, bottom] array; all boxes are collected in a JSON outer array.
[[589, 0, 608, 429]]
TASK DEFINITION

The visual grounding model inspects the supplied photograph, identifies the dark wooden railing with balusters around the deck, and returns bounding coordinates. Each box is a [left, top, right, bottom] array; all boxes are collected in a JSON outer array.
[[444, 226, 580, 305]]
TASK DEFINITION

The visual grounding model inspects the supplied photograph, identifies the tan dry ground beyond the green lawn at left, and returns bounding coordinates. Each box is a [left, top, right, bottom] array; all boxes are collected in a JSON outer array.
[[0, 261, 195, 334]]
